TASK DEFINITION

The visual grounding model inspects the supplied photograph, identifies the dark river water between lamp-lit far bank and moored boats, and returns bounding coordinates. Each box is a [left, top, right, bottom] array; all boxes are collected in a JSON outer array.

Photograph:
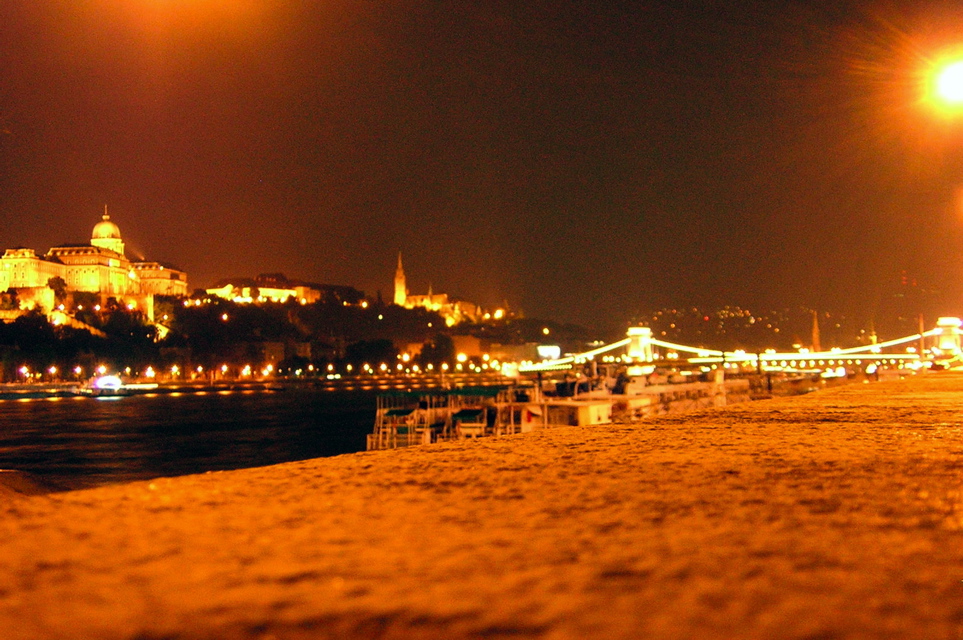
[[0, 388, 377, 489]]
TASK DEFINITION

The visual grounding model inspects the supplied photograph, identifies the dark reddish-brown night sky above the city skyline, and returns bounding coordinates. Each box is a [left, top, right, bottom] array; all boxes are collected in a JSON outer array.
[[0, 0, 963, 336]]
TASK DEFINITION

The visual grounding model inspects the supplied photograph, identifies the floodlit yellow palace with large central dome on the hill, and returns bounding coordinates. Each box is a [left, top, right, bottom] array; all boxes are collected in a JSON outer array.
[[0, 211, 188, 306]]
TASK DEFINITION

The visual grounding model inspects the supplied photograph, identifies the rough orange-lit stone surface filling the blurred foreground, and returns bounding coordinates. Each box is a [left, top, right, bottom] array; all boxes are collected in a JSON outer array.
[[0, 373, 963, 640]]
